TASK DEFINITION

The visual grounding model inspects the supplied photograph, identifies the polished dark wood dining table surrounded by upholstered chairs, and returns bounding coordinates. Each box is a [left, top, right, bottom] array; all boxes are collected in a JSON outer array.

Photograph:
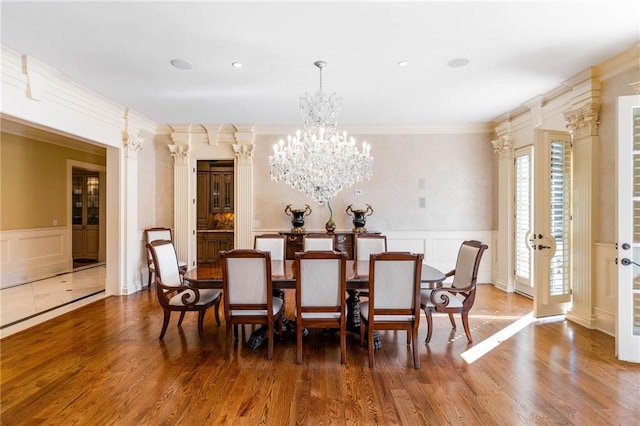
[[183, 259, 446, 349]]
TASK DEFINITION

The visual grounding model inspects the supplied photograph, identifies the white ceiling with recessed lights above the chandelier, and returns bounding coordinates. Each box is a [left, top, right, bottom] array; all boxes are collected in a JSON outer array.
[[0, 0, 640, 127]]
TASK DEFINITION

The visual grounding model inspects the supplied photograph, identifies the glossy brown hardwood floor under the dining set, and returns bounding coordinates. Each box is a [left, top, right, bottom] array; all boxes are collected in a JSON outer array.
[[0, 285, 640, 425]]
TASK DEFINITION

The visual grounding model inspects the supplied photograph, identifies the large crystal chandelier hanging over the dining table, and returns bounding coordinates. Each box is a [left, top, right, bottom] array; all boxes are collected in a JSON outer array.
[[269, 61, 373, 204]]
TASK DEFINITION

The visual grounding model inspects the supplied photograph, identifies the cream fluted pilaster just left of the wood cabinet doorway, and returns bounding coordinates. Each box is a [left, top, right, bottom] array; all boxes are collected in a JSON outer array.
[[169, 144, 196, 268]]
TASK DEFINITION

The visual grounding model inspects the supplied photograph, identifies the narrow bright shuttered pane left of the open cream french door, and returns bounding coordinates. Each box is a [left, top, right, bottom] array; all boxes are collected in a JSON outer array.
[[515, 155, 533, 286]]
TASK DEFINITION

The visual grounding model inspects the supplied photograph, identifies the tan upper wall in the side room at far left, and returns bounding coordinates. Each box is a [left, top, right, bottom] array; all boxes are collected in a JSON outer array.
[[0, 133, 106, 231]]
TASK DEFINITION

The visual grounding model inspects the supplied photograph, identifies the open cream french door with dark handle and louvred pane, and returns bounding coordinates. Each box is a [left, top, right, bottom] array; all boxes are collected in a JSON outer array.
[[528, 130, 572, 317]]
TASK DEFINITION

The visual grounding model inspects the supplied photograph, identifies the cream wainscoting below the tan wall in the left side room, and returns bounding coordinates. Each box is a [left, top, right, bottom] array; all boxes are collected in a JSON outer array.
[[0, 227, 73, 288]]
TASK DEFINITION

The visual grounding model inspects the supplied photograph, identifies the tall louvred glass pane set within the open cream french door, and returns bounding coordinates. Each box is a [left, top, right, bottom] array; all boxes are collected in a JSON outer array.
[[549, 141, 571, 296]]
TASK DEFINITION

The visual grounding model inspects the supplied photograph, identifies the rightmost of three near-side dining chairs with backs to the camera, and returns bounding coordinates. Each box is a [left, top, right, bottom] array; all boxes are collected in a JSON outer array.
[[360, 252, 424, 368]]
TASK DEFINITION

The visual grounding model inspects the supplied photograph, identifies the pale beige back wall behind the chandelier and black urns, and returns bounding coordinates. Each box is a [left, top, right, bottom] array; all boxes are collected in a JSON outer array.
[[253, 134, 495, 232]]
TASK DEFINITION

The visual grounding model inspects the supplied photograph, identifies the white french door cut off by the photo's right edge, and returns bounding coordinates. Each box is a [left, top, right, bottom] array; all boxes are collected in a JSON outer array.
[[616, 96, 640, 362]]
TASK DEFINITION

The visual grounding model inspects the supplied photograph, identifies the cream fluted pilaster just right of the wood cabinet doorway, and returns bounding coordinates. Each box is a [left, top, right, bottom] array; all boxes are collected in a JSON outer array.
[[233, 144, 255, 248]]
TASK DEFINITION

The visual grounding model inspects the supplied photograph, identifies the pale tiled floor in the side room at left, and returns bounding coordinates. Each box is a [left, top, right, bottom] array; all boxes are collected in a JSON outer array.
[[0, 264, 106, 338]]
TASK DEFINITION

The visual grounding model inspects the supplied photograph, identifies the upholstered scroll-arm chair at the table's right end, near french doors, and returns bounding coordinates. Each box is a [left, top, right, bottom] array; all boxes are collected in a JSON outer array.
[[420, 240, 488, 343]]
